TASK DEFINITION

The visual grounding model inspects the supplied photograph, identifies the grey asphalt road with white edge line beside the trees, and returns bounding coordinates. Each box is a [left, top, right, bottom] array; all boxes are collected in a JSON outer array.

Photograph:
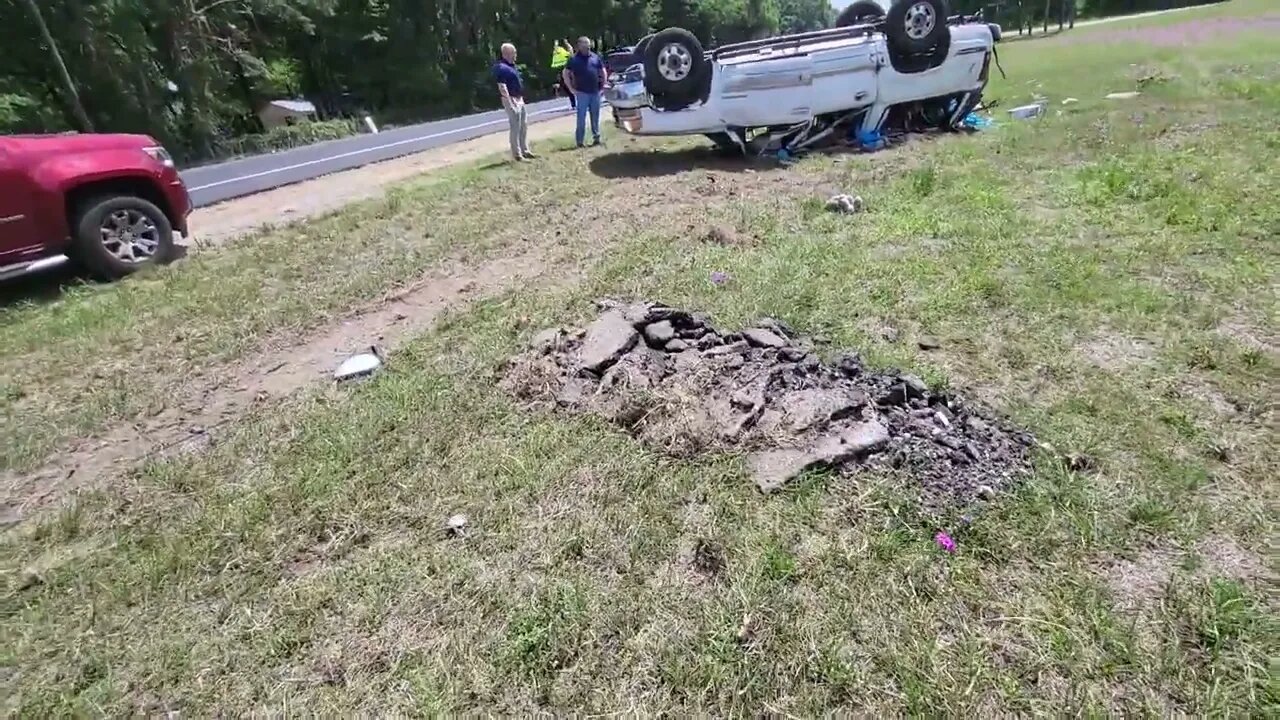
[[180, 100, 570, 208]]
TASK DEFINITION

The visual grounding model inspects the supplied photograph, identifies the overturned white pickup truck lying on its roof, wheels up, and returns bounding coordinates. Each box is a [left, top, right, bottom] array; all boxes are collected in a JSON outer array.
[[605, 0, 1000, 152]]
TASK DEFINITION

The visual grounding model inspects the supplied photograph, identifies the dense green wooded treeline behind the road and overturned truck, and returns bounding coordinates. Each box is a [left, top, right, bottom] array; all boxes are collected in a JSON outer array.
[[0, 0, 1213, 160]]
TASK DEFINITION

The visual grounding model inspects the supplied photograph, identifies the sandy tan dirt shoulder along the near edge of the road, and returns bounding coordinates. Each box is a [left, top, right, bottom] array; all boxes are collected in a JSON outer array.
[[191, 118, 573, 243]]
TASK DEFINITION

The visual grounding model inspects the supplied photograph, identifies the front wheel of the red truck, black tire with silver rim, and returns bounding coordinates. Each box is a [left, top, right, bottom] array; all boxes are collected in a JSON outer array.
[[68, 195, 173, 281]]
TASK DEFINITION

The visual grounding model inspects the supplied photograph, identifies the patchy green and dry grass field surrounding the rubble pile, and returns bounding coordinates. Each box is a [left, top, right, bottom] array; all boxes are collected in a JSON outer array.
[[0, 0, 1280, 716]]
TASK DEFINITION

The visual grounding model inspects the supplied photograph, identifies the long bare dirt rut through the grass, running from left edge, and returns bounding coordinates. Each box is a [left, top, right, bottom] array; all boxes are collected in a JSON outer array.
[[0, 247, 560, 525]]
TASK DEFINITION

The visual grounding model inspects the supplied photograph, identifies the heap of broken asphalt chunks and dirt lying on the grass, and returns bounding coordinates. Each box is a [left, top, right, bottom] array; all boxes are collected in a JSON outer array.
[[502, 301, 1036, 506]]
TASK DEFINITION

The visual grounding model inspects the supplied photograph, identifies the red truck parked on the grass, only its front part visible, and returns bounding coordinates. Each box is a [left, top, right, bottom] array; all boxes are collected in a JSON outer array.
[[0, 133, 191, 279]]
